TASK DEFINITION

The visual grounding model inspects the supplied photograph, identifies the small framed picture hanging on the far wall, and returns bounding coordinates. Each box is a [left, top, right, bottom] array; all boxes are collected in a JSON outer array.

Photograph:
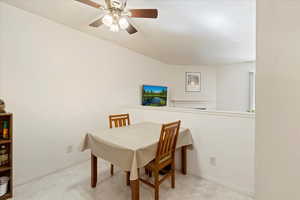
[[185, 72, 201, 92]]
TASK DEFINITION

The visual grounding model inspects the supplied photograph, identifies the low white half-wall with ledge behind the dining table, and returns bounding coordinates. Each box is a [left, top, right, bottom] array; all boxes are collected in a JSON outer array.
[[124, 106, 255, 195]]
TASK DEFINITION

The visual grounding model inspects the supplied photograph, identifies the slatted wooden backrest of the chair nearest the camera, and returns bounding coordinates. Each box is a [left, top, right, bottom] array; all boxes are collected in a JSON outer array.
[[155, 121, 181, 163]]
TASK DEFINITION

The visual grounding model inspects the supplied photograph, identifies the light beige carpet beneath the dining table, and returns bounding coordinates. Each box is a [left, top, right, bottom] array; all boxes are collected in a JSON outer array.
[[14, 162, 253, 200]]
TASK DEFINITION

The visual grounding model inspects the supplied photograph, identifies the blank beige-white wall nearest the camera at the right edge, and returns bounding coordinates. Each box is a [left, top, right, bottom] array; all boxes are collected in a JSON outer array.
[[256, 0, 300, 200]]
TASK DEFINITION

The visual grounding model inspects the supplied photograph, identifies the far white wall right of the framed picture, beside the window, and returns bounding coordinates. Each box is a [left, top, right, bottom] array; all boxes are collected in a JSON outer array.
[[216, 62, 255, 112]]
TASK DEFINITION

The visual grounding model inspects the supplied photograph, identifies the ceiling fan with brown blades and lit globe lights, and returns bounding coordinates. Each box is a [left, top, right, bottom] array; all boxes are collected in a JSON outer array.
[[75, 0, 158, 34]]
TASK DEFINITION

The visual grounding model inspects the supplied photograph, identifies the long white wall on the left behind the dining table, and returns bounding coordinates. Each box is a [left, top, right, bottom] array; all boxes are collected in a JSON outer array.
[[0, 3, 170, 184]]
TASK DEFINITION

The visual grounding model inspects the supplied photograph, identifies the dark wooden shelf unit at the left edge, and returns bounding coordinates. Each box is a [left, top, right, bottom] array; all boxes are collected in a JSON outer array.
[[0, 113, 13, 200]]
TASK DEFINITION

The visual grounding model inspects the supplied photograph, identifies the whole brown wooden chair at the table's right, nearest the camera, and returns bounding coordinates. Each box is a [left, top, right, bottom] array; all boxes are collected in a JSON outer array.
[[139, 121, 181, 200]]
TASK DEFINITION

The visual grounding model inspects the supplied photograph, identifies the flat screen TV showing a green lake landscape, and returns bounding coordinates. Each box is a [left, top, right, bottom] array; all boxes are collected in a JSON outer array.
[[142, 85, 168, 106]]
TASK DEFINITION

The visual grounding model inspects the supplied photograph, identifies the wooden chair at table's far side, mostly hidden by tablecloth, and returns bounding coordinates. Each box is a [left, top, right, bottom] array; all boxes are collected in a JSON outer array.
[[109, 114, 130, 185]]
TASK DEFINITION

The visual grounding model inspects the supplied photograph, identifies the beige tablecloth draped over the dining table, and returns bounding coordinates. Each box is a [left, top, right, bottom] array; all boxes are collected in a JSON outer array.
[[81, 122, 193, 180]]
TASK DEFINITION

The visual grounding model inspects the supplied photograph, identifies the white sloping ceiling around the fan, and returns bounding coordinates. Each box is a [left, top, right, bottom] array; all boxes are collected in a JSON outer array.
[[1, 0, 256, 65]]
